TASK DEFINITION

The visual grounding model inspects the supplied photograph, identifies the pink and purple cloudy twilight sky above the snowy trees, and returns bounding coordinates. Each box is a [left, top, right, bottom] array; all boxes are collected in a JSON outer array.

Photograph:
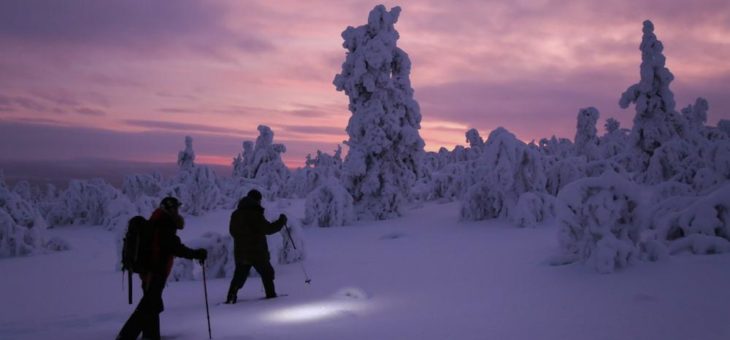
[[0, 0, 730, 173]]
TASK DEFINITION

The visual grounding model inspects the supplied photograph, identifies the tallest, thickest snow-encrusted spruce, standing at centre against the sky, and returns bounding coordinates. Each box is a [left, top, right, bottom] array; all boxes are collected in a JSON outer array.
[[333, 5, 425, 219]]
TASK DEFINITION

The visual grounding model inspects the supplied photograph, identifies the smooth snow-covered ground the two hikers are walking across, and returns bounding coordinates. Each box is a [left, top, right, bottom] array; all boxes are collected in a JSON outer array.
[[0, 202, 730, 340]]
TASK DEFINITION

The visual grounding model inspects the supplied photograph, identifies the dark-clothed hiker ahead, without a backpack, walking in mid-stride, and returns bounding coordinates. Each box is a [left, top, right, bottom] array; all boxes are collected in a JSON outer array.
[[226, 189, 287, 304]]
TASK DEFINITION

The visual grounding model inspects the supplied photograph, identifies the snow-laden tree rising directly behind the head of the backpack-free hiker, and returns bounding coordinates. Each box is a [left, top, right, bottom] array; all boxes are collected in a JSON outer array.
[[233, 125, 289, 197]]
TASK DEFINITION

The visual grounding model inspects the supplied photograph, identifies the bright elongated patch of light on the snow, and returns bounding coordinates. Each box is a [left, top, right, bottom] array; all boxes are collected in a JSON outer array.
[[265, 301, 359, 323]]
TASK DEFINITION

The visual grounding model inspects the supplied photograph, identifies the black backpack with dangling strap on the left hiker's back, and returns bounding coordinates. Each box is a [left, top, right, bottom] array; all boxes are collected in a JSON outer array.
[[122, 216, 153, 304]]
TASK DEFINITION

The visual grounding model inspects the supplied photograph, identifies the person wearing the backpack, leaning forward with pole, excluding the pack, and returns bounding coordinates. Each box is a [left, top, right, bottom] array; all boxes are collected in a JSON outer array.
[[117, 197, 208, 340]]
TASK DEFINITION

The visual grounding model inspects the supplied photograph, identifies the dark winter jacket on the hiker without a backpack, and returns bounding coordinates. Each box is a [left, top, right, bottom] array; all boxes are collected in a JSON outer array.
[[229, 197, 284, 266]]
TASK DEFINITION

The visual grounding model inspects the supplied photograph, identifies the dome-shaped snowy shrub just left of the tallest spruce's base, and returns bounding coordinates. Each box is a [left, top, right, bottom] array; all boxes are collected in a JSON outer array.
[[304, 179, 354, 227]]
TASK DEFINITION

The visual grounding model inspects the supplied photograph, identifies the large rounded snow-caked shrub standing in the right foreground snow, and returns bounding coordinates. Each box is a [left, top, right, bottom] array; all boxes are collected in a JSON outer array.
[[556, 172, 641, 273]]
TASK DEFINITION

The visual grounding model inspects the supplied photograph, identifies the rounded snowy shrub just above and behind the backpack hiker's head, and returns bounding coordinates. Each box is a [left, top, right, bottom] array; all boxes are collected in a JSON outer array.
[[162, 166, 225, 216]]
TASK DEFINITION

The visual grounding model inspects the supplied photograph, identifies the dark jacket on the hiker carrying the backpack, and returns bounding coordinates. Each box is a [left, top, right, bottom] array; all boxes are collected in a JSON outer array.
[[143, 209, 195, 280]]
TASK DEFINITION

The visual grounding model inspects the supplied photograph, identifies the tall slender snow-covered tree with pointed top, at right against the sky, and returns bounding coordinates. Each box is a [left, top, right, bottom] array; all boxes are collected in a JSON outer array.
[[619, 20, 683, 177]]
